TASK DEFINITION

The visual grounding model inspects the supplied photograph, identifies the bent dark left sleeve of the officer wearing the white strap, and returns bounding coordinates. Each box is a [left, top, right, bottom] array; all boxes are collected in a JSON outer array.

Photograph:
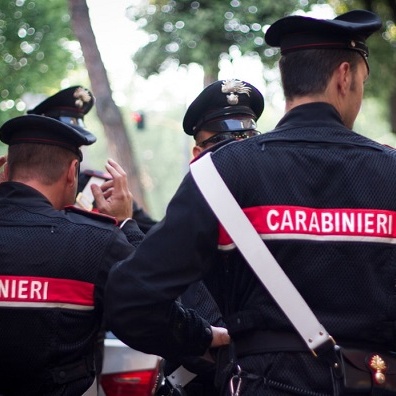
[[105, 175, 218, 360]]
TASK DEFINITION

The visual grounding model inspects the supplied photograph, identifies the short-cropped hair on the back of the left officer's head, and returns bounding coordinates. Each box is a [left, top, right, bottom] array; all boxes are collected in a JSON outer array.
[[7, 143, 79, 185]]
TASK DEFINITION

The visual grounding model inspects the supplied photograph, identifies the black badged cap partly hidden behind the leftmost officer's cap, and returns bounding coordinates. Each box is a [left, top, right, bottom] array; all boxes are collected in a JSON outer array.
[[27, 85, 96, 141]]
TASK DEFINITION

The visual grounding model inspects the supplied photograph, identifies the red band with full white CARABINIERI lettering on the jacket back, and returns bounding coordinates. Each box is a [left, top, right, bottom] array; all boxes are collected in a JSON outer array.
[[218, 205, 396, 250]]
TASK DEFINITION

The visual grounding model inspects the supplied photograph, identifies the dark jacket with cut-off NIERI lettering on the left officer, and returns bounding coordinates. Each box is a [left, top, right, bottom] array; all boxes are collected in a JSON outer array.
[[0, 182, 143, 396]]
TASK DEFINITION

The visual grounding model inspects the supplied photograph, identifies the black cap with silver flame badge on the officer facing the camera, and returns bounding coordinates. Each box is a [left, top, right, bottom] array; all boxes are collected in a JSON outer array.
[[183, 79, 264, 136]]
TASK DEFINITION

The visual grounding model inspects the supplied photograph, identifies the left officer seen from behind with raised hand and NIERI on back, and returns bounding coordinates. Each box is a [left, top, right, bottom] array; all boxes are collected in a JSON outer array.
[[0, 115, 143, 396]]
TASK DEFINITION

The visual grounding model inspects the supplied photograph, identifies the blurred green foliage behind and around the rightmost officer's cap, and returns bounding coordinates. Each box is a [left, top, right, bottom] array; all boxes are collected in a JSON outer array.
[[128, 0, 396, 100]]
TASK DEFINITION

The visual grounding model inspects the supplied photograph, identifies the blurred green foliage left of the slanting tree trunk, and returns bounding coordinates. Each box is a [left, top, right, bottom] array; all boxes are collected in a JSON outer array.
[[0, 0, 78, 123]]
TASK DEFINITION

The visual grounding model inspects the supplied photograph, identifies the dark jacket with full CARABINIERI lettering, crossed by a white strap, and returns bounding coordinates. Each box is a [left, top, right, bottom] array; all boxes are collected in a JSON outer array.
[[106, 103, 396, 378]]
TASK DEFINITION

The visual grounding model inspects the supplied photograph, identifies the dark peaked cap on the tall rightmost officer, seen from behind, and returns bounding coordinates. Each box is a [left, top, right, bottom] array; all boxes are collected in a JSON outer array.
[[265, 10, 382, 58]]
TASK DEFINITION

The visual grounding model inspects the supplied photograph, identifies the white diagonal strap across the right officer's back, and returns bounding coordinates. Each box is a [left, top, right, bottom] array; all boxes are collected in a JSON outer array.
[[190, 153, 332, 353]]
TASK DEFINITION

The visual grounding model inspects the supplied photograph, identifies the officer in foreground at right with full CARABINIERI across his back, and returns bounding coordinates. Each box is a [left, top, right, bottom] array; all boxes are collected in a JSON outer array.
[[106, 10, 388, 396]]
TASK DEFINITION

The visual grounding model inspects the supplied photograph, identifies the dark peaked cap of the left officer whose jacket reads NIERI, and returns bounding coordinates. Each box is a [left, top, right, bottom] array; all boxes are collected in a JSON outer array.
[[0, 114, 96, 157]]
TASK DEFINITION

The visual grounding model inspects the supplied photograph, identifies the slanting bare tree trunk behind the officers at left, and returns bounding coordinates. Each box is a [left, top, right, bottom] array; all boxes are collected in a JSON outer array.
[[69, 0, 144, 206]]
